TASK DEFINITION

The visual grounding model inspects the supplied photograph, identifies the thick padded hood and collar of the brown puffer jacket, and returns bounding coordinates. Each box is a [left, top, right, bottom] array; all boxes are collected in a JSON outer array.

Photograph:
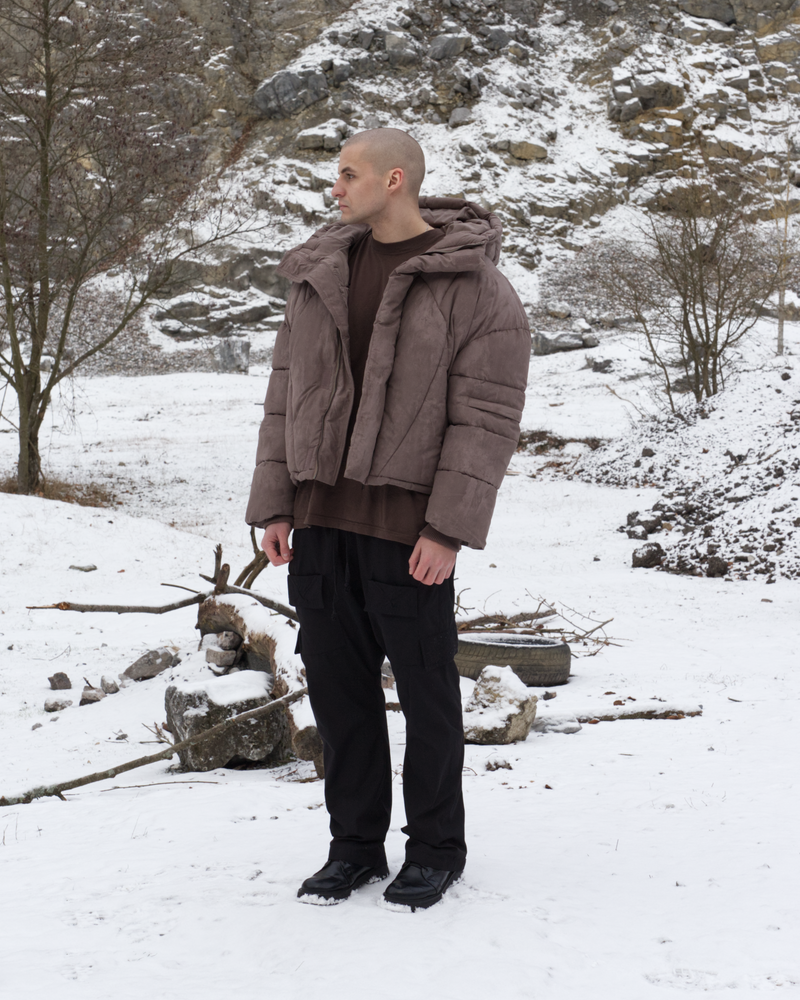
[[278, 198, 503, 281]]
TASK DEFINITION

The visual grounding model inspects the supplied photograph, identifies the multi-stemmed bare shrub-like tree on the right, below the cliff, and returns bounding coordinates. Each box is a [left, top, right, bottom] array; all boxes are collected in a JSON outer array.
[[550, 179, 778, 412]]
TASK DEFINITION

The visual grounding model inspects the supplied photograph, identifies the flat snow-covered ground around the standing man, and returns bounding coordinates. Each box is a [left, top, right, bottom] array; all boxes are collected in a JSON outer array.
[[0, 336, 800, 1000]]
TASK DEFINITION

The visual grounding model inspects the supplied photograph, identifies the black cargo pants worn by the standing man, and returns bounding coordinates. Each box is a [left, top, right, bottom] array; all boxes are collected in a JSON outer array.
[[289, 527, 466, 871]]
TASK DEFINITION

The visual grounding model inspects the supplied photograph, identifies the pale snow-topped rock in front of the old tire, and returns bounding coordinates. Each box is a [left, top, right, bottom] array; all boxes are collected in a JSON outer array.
[[464, 667, 539, 744]]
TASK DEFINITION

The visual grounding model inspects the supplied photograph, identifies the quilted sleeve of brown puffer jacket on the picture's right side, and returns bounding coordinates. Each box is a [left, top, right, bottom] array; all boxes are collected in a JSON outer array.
[[426, 272, 531, 549]]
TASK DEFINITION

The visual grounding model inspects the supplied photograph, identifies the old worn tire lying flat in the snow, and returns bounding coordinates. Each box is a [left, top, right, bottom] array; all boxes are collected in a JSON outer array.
[[456, 632, 572, 687]]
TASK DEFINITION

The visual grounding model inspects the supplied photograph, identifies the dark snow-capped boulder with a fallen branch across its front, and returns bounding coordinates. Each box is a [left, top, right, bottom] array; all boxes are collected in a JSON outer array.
[[164, 670, 291, 771]]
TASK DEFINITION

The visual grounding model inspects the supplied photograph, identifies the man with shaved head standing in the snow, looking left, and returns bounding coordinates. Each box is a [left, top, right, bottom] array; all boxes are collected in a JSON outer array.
[[247, 129, 530, 910]]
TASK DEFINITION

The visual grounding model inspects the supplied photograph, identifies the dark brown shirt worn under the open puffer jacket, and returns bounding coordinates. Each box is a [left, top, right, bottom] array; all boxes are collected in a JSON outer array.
[[290, 229, 461, 549]]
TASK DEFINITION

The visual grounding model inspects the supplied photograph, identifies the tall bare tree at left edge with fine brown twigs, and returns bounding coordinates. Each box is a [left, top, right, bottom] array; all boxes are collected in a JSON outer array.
[[0, 0, 256, 493]]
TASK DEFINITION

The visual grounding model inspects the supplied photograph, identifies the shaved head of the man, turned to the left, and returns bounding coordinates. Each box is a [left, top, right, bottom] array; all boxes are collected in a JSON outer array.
[[331, 128, 425, 226]]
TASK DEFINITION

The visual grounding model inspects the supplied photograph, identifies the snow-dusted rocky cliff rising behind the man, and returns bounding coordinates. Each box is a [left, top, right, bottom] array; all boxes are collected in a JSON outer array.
[[144, 0, 800, 352]]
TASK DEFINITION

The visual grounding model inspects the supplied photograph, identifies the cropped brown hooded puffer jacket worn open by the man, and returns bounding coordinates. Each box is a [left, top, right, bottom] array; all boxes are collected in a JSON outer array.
[[246, 198, 531, 549]]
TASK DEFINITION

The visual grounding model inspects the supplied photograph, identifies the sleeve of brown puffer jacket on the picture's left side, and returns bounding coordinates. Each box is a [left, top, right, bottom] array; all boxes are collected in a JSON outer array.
[[245, 284, 301, 528]]
